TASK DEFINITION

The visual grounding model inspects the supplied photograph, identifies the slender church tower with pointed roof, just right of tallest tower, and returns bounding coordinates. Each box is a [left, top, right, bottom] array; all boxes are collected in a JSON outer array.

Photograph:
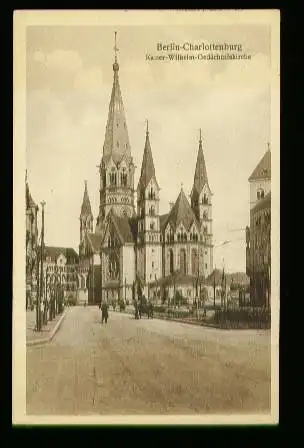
[[137, 121, 161, 283]]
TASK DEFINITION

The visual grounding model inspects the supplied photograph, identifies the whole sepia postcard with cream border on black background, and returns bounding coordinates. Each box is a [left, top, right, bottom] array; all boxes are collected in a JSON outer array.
[[12, 10, 280, 425]]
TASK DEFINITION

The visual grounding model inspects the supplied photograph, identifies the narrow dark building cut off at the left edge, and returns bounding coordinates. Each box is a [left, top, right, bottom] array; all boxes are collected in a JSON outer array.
[[25, 176, 39, 309]]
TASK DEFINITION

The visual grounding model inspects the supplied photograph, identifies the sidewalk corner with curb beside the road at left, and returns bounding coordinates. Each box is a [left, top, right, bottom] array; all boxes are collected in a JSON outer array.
[[26, 310, 67, 345]]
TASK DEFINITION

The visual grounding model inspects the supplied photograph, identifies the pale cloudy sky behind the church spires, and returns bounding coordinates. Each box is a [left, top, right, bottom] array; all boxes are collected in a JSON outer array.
[[26, 25, 271, 272]]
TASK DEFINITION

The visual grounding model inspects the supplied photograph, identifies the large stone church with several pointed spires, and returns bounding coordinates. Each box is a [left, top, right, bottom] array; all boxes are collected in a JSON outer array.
[[79, 36, 213, 303]]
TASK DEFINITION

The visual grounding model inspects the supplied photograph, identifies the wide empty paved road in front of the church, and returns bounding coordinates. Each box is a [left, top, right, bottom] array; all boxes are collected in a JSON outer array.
[[27, 307, 270, 415]]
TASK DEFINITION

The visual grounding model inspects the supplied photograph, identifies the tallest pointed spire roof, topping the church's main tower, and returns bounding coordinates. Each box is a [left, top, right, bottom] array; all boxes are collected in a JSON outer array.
[[103, 32, 131, 163]]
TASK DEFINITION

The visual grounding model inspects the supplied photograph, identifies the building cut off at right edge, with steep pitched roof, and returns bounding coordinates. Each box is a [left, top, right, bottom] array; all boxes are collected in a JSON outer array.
[[246, 145, 271, 307]]
